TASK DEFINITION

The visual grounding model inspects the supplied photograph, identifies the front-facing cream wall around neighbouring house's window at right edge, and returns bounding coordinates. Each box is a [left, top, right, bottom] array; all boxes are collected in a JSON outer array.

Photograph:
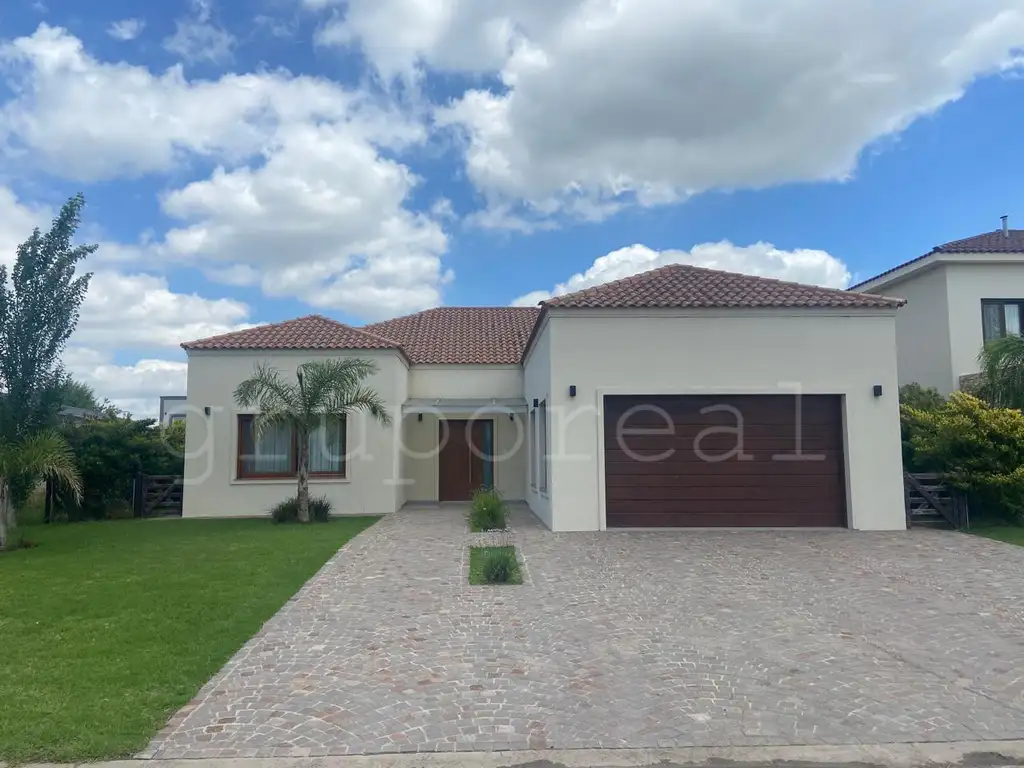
[[940, 256, 1024, 394]]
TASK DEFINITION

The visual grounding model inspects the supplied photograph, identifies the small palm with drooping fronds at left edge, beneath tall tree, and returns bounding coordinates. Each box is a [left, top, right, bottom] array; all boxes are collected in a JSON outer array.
[[0, 432, 82, 550]]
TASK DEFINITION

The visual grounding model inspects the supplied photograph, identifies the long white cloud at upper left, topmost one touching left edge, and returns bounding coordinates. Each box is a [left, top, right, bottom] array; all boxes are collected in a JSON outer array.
[[0, 25, 365, 181]]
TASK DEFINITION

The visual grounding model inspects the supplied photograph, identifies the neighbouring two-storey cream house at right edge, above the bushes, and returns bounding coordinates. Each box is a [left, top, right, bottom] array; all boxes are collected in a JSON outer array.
[[850, 219, 1024, 395]]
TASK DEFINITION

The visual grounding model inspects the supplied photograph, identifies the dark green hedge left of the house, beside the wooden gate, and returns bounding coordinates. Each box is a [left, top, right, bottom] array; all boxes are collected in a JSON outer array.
[[56, 417, 184, 520]]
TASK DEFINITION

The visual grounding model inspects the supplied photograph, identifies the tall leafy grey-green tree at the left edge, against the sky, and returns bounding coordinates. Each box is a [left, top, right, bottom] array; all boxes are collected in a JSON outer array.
[[0, 195, 96, 442]]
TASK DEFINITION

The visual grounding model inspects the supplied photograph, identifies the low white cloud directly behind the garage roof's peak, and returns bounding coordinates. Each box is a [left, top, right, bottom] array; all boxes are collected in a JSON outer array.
[[512, 241, 850, 306]]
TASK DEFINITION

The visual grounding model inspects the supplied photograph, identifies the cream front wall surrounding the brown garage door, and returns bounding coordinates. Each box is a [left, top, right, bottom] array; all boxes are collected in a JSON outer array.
[[544, 309, 905, 530]]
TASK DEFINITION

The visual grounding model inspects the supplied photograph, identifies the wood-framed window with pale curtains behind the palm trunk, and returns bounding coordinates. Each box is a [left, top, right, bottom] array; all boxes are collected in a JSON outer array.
[[237, 414, 347, 479]]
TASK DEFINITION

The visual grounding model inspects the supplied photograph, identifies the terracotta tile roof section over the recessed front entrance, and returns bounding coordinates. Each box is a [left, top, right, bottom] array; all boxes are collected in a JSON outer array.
[[364, 306, 541, 366]]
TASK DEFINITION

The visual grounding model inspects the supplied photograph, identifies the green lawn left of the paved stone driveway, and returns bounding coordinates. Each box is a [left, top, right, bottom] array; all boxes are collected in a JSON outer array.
[[0, 517, 377, 762]]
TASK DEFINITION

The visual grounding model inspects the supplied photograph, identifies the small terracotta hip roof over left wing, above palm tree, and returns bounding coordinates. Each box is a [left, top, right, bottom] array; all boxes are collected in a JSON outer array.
[[181, 314, 400, 349]]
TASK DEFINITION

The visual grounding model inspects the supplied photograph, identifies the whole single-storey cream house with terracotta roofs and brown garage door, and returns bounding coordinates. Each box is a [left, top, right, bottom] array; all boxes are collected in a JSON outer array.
[[182, 265, 905, 530]]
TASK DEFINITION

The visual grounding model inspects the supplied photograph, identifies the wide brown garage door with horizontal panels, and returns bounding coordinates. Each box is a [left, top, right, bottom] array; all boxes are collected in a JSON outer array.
[[604, 395, 846, 527]]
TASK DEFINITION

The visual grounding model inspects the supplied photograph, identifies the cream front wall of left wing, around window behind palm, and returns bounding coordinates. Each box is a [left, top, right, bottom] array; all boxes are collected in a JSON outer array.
[[183, 350, 408, 517]]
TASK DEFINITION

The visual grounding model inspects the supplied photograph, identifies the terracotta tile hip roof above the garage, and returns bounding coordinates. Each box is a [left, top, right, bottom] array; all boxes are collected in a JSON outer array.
[[543, 264, 905, 308]]
